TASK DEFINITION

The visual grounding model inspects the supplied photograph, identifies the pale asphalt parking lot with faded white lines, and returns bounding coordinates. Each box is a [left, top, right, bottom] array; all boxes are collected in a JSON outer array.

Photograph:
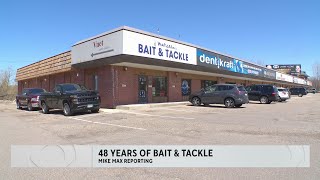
[[0, 94, 320, 179]]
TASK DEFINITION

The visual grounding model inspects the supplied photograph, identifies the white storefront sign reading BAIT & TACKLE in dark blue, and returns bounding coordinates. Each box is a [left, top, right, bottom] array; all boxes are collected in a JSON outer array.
[[123, 31, 196, 65]]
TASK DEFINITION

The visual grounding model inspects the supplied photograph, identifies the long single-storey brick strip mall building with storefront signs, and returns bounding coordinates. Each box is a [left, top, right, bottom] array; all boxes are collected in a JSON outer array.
[[16, 27, 312, 108]]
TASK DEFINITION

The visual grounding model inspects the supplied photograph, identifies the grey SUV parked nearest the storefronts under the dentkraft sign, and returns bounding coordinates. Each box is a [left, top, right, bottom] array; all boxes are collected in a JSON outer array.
[[189, 84, 249, 108]]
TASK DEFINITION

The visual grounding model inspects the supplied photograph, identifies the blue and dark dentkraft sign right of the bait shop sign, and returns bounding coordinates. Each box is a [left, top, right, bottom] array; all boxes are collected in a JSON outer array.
[[197, 49, 264, 77]]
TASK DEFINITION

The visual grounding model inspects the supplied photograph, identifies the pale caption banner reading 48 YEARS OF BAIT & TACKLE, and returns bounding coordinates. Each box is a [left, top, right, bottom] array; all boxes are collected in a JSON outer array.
[[11, 145, 310, 168]]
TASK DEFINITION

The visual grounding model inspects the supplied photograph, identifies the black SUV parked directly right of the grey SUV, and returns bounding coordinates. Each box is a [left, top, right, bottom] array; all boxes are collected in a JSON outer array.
[[246, 84, 280, 104]]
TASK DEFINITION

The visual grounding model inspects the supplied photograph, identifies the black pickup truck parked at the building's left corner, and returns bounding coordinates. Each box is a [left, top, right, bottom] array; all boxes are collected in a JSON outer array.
[[39, 84, 101, 116]]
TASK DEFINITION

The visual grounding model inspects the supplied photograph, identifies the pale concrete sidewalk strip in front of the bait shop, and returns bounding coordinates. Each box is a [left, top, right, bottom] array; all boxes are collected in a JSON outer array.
[[112, 101, 190, 110]]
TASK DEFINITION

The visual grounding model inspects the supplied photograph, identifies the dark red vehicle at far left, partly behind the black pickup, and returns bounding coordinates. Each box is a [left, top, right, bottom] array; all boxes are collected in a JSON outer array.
[[16, 88, 46, 111]]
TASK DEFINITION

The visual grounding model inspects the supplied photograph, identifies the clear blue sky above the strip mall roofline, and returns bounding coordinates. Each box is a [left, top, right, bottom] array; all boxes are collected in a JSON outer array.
[[0, 0, 320, 76]]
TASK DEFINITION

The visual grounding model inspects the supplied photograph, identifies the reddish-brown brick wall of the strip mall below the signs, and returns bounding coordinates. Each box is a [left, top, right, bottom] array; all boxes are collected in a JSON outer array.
[[18, 65, 292, 108]]
